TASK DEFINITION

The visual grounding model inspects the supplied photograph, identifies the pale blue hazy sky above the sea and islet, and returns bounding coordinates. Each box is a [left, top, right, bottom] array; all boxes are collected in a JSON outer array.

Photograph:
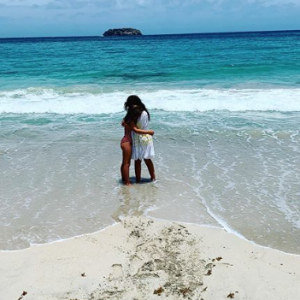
[[0, 0, 300, 38]]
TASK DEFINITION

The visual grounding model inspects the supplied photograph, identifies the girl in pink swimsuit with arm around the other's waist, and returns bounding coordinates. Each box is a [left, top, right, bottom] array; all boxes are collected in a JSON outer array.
[[121, 106, 154, 185]]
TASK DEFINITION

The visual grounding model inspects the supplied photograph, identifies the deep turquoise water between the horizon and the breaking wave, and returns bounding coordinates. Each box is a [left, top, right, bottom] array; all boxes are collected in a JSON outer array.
[[0, 31, 300, 90]]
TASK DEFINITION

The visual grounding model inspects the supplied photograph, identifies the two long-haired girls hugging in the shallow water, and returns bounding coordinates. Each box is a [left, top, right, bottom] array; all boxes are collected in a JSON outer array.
[[121, 95, 155, 185]]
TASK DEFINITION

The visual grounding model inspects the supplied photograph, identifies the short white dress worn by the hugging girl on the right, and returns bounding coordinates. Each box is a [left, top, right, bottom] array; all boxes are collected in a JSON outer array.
[[131, 111, 155, 160]]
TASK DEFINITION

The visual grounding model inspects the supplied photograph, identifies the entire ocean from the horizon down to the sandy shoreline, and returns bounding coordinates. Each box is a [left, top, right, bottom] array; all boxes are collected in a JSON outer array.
[[0, 31, 300, 254]]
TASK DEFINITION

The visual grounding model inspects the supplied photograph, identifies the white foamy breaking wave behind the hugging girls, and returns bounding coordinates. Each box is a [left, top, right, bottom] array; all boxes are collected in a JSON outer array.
[[0, 88, 300, 114]]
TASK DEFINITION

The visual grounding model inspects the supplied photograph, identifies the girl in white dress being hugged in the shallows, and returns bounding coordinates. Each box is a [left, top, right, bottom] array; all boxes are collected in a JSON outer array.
[[124, 95, 155, 183]]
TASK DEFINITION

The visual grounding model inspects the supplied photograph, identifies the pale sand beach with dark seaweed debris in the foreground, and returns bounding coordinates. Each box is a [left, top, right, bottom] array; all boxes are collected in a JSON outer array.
[[0, 217, 300, 300]]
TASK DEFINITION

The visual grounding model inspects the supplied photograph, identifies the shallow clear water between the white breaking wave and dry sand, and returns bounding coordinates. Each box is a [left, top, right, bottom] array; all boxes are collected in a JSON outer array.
[[0, 111, 300, 253]]
